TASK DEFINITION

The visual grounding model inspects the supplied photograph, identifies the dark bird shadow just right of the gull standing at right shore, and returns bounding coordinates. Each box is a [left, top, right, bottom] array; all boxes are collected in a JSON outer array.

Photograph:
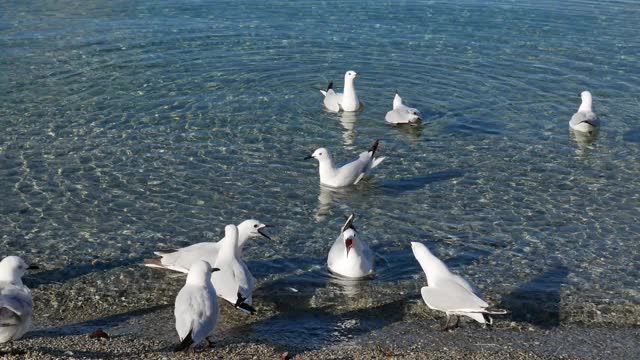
[[497, 265, 569, 328]]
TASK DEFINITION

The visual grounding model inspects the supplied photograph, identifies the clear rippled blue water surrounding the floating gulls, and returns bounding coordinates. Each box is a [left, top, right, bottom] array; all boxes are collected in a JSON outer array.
[[0, 0, 640, 348]]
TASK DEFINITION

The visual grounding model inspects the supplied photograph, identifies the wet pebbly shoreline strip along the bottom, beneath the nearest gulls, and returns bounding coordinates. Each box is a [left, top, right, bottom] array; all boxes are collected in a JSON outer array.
[[0, 265, 640, 359]]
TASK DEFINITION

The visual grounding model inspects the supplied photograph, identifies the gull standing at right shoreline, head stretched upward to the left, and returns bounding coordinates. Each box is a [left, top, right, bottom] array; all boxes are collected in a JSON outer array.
[[411, 242, 507, 330]]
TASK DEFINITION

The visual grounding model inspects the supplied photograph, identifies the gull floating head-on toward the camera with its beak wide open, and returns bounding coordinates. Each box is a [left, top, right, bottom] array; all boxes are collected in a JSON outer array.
[[327, 214, 374, 279]]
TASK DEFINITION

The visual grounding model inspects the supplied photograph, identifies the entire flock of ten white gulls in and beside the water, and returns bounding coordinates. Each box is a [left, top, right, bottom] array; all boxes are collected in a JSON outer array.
[[0, 71, 599, 351]]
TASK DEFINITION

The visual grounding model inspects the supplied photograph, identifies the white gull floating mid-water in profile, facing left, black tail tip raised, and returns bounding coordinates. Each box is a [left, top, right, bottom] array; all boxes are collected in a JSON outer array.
[[304, 140, 385, 188]]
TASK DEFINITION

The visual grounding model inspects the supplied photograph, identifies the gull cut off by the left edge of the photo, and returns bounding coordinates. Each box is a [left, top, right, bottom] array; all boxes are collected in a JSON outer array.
[[0, 256, 37, 344]]
